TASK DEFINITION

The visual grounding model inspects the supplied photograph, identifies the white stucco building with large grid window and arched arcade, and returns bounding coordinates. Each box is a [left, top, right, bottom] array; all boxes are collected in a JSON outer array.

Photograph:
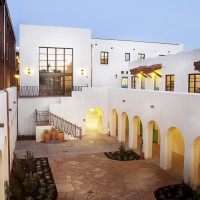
[[18, 25, 200, 185]]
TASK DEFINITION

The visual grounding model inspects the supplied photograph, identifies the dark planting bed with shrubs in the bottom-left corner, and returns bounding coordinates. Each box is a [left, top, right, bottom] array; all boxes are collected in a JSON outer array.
[[5, 151, 57, 200]]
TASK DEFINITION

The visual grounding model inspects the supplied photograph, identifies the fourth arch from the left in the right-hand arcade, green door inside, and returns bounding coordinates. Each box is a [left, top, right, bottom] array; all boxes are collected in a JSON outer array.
[[147, 121, 160, 165]]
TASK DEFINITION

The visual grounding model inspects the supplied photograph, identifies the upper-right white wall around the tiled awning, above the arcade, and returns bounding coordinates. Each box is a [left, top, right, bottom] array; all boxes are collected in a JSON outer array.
[[129, 50, 200, 92]]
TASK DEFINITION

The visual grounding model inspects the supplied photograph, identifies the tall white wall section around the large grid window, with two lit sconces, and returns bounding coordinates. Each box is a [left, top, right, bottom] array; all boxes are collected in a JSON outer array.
[[20, 25, 91, 86]]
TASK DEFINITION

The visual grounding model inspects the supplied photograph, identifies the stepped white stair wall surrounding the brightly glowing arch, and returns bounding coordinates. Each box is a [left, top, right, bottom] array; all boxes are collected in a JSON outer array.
[[50, 88, 108, 135]]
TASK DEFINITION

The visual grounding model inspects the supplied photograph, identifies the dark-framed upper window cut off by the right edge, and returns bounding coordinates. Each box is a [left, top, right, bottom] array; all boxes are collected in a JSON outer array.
[[188, 74, 200, 93]]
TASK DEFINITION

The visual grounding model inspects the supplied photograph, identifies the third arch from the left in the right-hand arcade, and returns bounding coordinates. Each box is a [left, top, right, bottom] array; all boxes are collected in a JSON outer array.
[[133, 116, 143, 152]]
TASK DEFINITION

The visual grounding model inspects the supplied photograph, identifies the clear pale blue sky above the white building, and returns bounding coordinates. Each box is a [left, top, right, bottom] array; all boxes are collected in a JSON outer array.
[[7, 0, 200, 51]]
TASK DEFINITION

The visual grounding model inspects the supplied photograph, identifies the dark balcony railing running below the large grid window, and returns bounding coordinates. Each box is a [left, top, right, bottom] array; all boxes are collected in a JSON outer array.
[[18, 86, 86, 97]]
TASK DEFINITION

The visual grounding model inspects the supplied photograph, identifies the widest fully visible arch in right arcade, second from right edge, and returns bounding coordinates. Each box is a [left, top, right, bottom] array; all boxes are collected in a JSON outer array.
[[165, 127, 185, 177]]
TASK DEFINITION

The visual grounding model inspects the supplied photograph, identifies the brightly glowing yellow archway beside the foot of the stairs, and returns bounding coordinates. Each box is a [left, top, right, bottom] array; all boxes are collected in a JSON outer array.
[[85, 108, 103, 135]]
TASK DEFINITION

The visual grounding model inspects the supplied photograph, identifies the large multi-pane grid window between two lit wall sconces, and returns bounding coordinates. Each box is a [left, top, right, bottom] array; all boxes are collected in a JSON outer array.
[[39, 47, 73, 96]]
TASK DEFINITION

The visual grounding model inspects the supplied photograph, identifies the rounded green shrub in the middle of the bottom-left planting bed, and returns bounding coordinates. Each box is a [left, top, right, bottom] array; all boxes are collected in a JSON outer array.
[[23, 172, 39, 193]]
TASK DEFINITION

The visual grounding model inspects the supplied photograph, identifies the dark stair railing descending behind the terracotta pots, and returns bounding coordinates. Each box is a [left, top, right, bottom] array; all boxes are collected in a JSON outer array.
[[36, 110, 82, 139]]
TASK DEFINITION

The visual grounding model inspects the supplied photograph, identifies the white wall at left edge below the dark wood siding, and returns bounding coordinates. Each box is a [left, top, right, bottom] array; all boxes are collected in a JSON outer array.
[[0, 87, 17, 199]]
